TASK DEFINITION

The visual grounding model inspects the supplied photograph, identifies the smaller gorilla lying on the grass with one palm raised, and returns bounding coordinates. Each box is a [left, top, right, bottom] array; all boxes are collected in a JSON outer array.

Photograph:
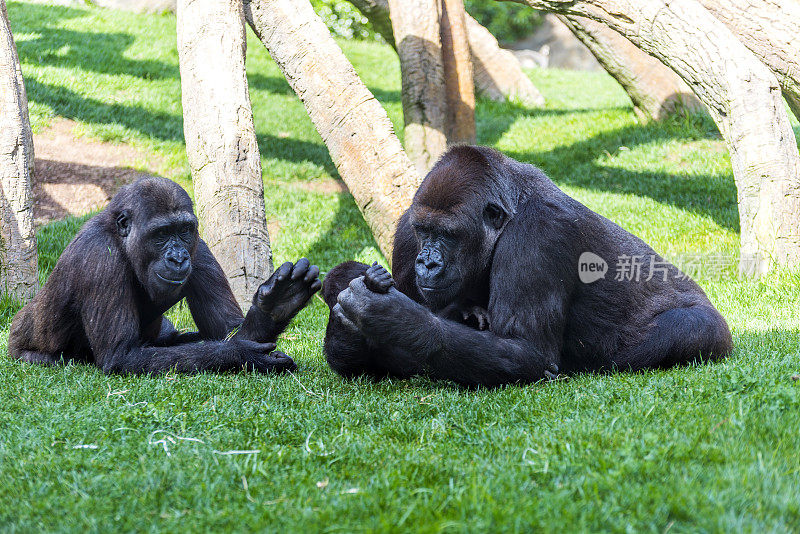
[[8, 178, 320, 373]]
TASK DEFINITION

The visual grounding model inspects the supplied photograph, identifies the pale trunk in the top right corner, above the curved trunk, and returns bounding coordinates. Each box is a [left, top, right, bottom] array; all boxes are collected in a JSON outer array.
[[700, 0, 800, 119]]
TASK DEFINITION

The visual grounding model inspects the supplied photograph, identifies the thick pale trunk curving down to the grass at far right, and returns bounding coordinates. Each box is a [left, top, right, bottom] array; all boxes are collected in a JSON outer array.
[[516, 0, 800, 274]]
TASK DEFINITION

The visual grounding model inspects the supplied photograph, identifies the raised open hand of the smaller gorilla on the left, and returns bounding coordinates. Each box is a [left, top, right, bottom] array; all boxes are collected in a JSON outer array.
[[253, 258, 322, 323]]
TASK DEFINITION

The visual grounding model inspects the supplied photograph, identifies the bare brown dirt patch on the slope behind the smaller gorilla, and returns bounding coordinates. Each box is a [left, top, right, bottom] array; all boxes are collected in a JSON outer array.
[[33, 119, 162, 225]]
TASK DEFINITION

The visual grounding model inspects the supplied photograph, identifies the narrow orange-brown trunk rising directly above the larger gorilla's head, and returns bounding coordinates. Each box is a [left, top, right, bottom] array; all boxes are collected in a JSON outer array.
[[440, 0, 475, 145]]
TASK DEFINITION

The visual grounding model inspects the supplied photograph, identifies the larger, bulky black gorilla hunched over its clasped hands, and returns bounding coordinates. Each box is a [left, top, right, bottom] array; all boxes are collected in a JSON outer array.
[[323, 147, 731, 385]]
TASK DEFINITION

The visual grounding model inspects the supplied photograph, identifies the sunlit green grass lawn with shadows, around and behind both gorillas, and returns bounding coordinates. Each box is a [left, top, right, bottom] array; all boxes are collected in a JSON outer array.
[[0, 3, 800, 532]]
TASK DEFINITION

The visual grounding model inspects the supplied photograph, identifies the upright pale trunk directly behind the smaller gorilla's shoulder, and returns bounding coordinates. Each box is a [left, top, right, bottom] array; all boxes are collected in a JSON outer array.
[[178, 0, 272, 311]]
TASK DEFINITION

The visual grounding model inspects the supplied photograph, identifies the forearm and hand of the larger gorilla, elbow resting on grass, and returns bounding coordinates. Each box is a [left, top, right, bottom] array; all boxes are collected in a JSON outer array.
[[334, 278, 563, 386]]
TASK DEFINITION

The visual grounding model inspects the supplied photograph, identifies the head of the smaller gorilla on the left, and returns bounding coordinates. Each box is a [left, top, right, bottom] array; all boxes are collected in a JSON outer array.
[[109, 178, 199, 302]]
